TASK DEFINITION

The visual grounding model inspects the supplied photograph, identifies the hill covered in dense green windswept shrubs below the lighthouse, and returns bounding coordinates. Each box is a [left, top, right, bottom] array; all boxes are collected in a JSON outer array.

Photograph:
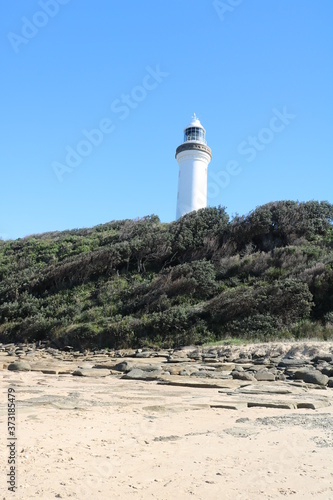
[[0, 201, 333, 348]]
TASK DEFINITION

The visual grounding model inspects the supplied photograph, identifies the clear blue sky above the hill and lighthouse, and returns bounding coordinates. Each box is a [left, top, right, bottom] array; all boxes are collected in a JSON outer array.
[[0, 0, 333, 238]]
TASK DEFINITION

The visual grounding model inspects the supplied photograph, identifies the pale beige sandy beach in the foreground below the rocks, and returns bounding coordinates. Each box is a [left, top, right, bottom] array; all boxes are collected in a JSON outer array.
[[0, 362, 333, 500]]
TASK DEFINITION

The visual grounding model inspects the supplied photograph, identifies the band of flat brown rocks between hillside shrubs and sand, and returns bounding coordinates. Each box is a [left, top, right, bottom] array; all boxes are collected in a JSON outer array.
[[0, 342, 333, 389]]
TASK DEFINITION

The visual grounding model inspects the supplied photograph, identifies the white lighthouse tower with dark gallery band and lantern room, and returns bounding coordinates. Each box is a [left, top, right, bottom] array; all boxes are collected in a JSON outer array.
[[176, 114, 212, 219]]
